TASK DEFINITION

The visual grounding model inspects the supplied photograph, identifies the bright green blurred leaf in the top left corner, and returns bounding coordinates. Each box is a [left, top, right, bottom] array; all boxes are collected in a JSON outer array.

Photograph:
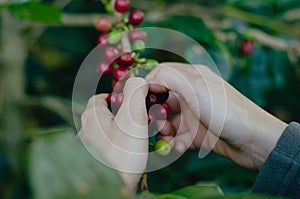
[[8, 1, 61, 23]]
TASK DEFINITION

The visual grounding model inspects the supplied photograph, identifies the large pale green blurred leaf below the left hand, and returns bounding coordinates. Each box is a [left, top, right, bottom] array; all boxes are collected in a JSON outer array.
[[29, 130, 122, 199]]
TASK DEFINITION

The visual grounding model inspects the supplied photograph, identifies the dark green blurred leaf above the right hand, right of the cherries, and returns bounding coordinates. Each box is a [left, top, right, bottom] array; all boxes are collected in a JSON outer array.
[[161, 16, 215, 44]]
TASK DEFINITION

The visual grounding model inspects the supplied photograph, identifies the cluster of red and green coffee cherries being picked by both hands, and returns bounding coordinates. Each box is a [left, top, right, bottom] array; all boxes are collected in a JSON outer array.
[[95, 0, 171, 156]]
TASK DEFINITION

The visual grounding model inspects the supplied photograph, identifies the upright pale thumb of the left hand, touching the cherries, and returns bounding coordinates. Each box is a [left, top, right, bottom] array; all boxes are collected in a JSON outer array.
[[115, 78, 148, 137]]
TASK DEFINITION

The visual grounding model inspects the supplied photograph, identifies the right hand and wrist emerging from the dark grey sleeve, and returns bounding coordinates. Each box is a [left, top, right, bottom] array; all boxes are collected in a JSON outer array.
[[146, 63, 287, 170]]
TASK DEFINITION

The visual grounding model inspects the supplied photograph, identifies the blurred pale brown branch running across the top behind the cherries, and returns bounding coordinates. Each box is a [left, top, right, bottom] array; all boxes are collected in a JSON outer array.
[[62, 9, 300, 56]]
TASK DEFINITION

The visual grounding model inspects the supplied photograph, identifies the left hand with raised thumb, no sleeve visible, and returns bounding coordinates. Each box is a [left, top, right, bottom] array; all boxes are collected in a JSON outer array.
[[78, 78, 148, 193]]
